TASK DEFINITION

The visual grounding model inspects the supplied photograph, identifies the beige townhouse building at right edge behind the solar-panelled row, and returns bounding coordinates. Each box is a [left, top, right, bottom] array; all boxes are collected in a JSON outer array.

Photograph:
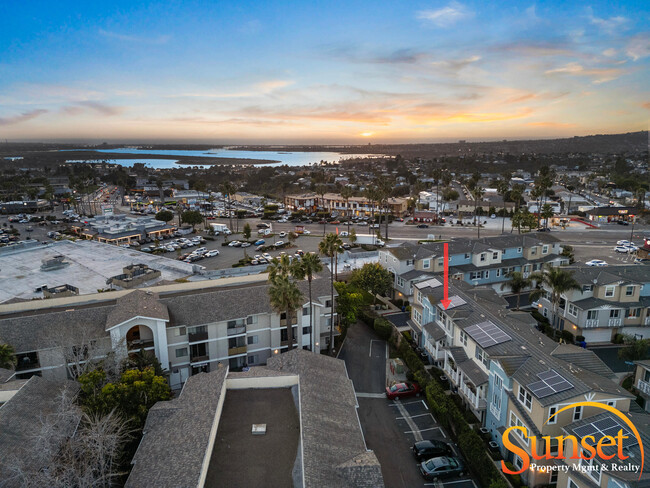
[[538, 265, 650, 344]]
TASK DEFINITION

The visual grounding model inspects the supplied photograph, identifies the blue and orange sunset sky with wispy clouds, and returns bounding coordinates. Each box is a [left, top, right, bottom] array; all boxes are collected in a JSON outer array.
[[0, 0, 650, 144]]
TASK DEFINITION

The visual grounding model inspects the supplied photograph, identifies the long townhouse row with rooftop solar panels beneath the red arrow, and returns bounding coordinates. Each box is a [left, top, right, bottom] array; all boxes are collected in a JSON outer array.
[[411, 278, 639, 487]]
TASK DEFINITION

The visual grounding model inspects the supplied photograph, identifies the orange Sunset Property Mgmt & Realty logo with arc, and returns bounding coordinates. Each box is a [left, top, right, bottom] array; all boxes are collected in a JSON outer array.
[[501, 401, 644, 479]]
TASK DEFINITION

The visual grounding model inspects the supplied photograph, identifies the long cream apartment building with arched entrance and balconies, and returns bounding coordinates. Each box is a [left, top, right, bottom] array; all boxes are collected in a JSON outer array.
[[0, 278, 336, 388]]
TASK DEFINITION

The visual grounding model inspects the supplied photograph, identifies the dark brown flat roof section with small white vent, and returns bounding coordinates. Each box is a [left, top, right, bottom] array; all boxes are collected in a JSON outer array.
[[205, 388, 300, 488]]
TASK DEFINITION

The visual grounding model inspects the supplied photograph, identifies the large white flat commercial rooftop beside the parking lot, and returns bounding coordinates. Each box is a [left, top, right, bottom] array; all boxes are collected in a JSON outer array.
[[0, 240, 193, 303]]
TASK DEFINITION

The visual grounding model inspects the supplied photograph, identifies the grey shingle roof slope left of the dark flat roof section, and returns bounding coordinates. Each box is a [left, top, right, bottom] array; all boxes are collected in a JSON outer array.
[[125, 366, 227, 488]]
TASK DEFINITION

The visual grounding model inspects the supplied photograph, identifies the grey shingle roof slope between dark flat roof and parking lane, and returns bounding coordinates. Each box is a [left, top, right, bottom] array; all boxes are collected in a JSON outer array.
[[267, 349, 384, 488]]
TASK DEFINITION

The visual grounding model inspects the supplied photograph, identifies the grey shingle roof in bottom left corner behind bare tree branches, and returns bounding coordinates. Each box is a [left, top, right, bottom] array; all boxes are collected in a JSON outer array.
[[0, 376, 79, 487]]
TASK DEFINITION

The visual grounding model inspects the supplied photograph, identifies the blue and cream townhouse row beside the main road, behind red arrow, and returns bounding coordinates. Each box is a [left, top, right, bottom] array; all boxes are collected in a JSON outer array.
[[379, 232, 569, 300]]
